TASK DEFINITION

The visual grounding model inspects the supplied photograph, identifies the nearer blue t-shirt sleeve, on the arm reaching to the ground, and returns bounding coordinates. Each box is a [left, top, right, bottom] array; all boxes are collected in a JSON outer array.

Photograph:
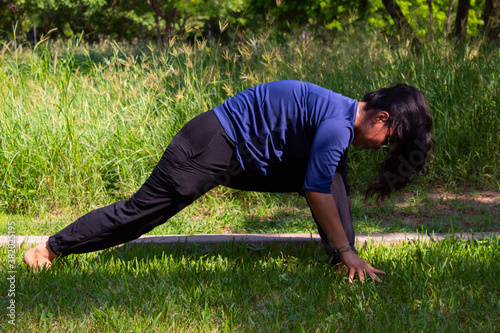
[[302, 119, 352, 193]]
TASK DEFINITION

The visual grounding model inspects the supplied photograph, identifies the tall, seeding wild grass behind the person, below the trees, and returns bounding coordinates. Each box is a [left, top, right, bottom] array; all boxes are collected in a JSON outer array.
[[0, 36, 500, 218]]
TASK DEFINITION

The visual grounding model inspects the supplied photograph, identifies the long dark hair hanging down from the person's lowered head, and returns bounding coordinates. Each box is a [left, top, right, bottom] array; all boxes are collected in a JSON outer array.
[[361, 84, 434, 199]]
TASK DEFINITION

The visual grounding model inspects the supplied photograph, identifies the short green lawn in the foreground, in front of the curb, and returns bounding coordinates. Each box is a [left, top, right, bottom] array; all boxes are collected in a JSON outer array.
[[0, 237, 500, 332]]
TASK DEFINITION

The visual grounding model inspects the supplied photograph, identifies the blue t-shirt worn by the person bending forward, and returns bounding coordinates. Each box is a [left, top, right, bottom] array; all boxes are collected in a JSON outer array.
[[214, 81, 358, 193]]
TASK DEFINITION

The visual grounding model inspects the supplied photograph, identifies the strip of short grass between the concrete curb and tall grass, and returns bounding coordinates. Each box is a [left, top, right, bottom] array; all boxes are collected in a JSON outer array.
[[0, 188, 500, 235]]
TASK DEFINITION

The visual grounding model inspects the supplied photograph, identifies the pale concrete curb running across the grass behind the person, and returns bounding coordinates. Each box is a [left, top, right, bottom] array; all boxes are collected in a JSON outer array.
[[0, 232, 500, 247]]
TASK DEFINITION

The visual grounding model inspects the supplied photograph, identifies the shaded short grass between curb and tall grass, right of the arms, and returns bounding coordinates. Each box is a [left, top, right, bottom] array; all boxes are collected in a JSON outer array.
[[353, 191, 500, 232]]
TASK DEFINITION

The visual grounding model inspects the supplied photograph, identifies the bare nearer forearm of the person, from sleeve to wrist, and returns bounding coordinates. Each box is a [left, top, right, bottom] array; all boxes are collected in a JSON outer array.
[[306, 191, 348, 248]]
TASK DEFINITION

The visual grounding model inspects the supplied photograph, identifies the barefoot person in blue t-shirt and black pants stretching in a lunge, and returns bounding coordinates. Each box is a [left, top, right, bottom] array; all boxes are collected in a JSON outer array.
[[24, 81, 433, 282]]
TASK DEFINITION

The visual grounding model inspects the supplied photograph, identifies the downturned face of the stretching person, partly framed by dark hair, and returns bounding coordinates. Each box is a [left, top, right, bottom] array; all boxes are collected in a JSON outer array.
[[352, 111, 391, 150]]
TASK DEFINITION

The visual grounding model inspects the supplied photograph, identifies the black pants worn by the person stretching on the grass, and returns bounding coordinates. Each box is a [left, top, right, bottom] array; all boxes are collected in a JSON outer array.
[[49, 111, 354, 256]]
